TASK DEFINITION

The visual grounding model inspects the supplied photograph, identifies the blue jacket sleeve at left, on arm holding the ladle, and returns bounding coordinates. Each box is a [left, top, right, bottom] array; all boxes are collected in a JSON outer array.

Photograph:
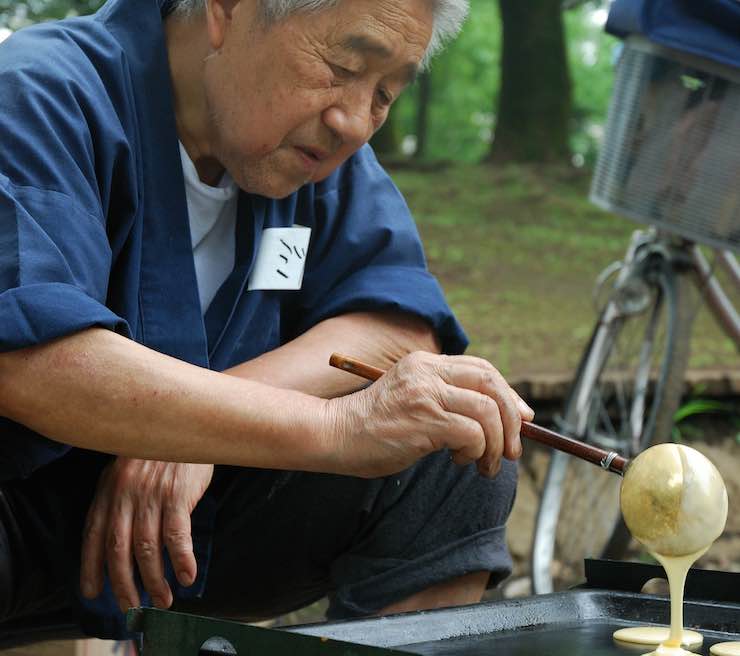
[[0, 26, 130, 480]]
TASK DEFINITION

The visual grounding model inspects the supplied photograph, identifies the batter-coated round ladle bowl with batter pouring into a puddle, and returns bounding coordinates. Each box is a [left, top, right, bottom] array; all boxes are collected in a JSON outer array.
[[614, 444, 724, 656]]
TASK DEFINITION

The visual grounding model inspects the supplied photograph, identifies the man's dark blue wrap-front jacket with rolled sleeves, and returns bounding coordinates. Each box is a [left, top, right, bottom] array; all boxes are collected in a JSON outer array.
[[0, 0, 466, 637]]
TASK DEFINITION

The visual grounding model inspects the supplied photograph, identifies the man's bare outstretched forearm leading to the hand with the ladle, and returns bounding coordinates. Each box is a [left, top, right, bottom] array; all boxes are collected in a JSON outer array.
[[0, 329, 332, 471]]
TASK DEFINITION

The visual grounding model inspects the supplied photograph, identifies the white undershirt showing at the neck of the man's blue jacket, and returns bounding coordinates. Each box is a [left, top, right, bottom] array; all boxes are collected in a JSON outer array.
[[180, 144, 239, 314]]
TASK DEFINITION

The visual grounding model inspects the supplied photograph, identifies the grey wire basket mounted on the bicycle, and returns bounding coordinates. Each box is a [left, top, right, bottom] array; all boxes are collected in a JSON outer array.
[[591, 37, 740, 250]]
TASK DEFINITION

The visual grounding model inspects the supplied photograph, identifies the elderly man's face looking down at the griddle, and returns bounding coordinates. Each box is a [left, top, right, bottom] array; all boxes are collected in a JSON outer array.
[[204, 0, 433, 198]]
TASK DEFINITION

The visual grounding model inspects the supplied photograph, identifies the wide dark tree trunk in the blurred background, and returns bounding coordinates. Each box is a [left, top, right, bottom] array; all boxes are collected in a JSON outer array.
[[491, 0, 571, 162]]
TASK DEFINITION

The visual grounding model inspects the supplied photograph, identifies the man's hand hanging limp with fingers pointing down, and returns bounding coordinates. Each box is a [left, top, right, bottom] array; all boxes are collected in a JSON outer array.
[[80, 457, 213, 611]]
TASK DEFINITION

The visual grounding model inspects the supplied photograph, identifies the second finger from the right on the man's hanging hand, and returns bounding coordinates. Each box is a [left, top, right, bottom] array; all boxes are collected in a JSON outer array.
[[133, 503, 172, 608]]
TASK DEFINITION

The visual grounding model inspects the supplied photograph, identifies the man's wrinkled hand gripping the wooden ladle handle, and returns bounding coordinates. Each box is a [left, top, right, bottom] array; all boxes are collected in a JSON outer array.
[[327, 352, 534, 477]]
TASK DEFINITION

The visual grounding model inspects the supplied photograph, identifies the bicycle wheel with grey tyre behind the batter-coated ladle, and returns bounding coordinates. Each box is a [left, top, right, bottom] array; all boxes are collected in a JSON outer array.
[[532, 258, 691, 593]]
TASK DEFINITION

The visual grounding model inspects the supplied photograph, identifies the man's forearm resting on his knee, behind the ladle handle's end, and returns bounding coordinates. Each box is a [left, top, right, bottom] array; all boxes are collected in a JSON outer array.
[[226, 312, 440, 398]]
